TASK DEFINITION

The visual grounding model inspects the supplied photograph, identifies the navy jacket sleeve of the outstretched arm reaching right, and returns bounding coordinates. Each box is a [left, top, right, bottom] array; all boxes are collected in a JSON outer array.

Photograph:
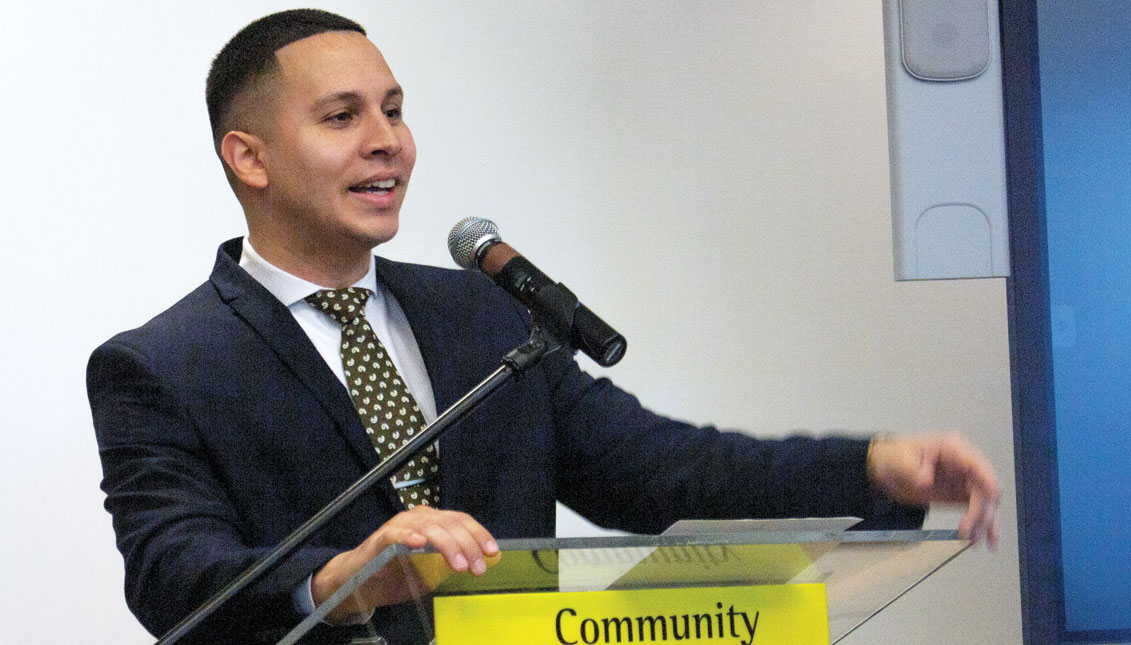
[[533, 339, 925, 533]]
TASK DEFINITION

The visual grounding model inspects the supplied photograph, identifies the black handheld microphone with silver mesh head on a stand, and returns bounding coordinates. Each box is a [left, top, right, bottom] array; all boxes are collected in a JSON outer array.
[[448, 217, 628, 368]]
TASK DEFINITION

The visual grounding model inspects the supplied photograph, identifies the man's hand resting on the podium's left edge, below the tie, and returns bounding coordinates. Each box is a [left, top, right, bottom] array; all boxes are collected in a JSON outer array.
[[310, 506, 499, 624]]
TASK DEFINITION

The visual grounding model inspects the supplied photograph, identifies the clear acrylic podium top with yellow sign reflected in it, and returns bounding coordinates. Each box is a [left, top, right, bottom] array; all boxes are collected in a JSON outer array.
[[279, 521, 969, 645]]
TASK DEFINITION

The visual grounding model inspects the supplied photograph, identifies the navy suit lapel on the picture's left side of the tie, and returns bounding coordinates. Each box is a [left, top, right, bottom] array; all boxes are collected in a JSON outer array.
[[210, 238, 384, 468]]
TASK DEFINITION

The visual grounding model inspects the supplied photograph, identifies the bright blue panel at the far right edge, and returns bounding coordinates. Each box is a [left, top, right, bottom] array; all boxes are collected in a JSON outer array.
[[1038, 0, 1131, 631]]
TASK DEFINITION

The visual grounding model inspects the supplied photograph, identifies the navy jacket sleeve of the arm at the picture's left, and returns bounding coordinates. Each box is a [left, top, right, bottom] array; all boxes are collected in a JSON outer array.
[[87, 339, 337, 642]]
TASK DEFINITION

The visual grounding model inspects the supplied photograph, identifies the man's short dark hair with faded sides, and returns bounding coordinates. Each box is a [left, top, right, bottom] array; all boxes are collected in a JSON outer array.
[[205, 9, 365, 151]]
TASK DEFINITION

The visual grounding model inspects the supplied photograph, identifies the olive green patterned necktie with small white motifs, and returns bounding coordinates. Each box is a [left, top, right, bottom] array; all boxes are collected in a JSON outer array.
[[307, 286, 440, 508]]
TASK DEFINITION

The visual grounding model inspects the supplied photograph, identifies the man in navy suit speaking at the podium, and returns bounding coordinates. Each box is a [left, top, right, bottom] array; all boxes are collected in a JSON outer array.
[[88, 9, 999, 643]]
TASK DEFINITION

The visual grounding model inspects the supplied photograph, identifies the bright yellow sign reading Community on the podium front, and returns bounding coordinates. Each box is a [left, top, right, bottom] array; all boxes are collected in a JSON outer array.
[[435, 584, 829, 645]]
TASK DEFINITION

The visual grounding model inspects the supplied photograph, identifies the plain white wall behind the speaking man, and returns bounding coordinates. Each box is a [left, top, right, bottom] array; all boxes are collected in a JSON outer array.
[[0, 0, 1020, 645]]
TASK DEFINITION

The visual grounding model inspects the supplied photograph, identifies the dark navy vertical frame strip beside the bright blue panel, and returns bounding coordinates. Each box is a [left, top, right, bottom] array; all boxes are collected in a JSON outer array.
[[1000, 0, 1064, 645]]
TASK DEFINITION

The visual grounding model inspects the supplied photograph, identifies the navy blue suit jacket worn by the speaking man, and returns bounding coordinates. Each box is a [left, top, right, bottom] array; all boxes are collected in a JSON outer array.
[[87, 240, 922, 643]]
